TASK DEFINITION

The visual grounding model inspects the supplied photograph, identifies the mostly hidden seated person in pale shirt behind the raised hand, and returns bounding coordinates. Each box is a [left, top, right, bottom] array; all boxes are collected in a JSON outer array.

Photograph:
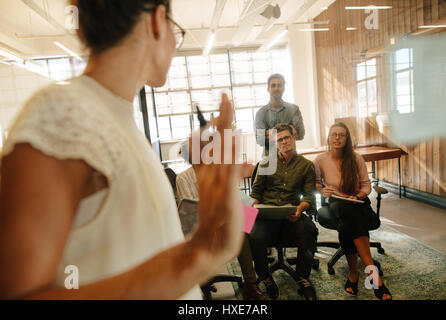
[[176, 142, 266, 300]]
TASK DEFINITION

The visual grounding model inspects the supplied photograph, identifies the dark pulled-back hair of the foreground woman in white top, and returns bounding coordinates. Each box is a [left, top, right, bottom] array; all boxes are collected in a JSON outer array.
[[71, 0, 170, 54]]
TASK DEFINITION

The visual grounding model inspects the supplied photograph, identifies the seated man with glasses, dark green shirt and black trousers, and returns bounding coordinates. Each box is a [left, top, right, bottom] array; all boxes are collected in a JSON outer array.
[[250, 123, 318, 300]]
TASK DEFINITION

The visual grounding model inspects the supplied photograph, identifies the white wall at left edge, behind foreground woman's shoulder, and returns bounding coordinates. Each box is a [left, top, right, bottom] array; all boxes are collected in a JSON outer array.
[[0, 64, 51, 143]]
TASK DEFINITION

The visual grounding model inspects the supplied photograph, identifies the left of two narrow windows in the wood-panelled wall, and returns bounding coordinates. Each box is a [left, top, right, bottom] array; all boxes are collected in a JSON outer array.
[[356, 58, 378, 118]]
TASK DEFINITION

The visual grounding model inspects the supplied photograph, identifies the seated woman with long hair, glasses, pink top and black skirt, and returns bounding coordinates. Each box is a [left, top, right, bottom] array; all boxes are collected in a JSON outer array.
[[314, 122, 392, 300]]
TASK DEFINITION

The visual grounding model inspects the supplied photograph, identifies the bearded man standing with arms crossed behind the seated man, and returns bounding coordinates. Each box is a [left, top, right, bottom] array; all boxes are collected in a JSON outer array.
[[255, 73, 305, 153]]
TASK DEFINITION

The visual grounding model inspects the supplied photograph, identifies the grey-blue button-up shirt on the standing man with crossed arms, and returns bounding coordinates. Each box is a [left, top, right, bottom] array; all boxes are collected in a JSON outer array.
[[254, 101, 305, 146]]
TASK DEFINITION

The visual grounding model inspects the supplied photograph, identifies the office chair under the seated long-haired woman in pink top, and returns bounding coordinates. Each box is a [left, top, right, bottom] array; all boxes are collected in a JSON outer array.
[[315, 186, 388, 276]]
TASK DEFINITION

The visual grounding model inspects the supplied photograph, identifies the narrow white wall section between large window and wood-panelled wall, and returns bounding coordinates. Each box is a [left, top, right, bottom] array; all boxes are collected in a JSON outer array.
[[288, 25, 321, 149]]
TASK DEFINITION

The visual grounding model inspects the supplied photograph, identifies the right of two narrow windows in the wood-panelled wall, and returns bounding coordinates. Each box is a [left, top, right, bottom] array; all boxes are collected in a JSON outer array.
[[393, 48, 414, 113]]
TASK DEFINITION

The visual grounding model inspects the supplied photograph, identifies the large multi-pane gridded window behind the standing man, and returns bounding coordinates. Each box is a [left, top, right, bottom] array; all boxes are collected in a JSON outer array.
[[146, 49, 294, 141]]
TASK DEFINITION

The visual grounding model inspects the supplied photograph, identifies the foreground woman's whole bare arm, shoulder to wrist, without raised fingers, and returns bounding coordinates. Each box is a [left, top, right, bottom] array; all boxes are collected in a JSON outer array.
[[0, 144, 209, 299]]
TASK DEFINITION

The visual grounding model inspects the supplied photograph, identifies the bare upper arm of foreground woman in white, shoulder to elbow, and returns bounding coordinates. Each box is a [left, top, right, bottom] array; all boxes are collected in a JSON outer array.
[[0, 144, 91, 298]]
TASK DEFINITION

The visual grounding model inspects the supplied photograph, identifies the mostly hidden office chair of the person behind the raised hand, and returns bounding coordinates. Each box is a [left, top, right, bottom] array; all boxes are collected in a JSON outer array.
[[178, 199, 242, 300]]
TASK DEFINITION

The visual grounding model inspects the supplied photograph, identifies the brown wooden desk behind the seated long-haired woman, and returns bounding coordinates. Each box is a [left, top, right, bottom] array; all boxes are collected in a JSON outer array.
[[300, 146, 403, 198]]
